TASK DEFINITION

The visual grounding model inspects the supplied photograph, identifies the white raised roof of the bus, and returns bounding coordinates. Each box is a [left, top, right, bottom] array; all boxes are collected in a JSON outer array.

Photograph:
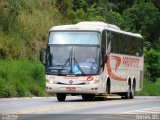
[[50, 21, 142, 38]]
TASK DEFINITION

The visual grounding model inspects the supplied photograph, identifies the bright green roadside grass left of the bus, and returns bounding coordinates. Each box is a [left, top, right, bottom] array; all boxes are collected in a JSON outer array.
[[0, 59, 47, 98]]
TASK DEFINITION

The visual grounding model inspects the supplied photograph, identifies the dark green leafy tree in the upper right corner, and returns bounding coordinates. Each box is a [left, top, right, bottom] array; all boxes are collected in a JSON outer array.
[[122, 0, 160, 50]]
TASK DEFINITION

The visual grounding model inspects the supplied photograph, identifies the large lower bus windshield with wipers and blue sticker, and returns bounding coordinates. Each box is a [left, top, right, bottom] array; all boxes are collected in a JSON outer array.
[[46, 45, 99, 75]]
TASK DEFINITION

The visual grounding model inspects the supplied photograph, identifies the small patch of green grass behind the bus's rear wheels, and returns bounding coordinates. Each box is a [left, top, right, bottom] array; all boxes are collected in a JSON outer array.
[[136, 79, 160, 96]]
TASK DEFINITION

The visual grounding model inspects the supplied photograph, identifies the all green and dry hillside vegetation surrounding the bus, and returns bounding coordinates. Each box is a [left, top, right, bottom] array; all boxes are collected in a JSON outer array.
[[0, 0, 160, 97]]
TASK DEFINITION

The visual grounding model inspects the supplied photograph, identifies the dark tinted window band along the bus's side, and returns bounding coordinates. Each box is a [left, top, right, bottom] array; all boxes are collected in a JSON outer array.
[[107, 31, 143, 56]]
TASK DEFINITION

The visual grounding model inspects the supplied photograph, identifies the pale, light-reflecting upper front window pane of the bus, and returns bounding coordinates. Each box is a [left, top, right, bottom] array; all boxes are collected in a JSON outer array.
[[49, 31, 100, 45]]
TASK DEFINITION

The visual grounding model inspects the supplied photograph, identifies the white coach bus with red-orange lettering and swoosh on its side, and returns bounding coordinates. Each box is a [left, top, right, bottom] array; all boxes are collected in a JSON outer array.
[[40, 22, 144, 101]]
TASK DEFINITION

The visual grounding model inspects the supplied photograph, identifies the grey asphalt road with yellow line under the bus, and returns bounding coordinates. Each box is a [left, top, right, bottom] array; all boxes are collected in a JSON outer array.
[[0, 96, 160, 120]]
